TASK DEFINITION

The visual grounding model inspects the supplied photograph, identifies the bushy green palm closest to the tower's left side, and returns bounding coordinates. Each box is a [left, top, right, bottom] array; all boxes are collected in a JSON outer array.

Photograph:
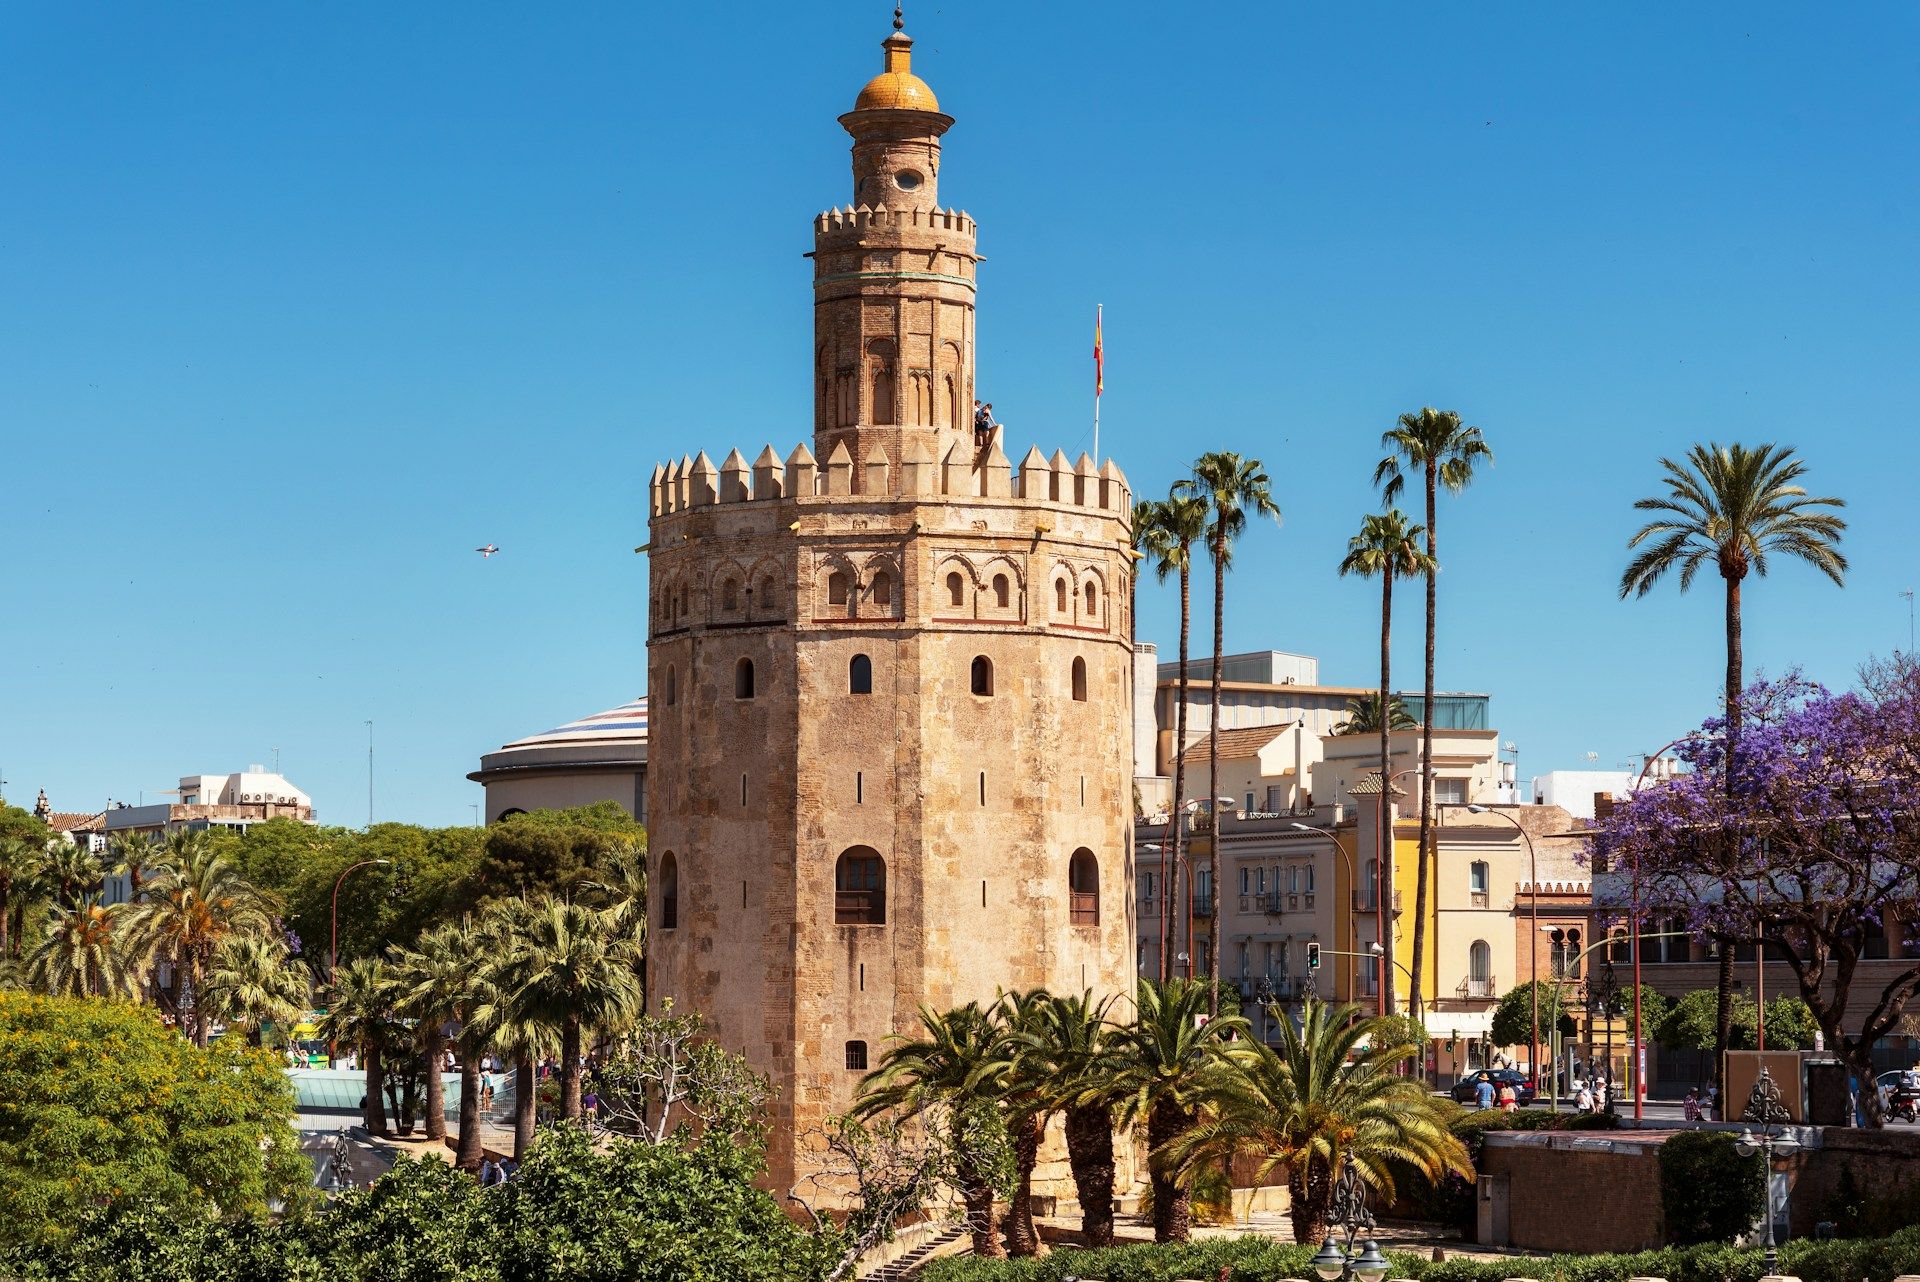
[[495, 896, 641, 1119]]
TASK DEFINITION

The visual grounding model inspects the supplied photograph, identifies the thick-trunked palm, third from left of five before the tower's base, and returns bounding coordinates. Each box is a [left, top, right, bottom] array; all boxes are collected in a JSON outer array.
[[1023, 992, 1117, 1247]]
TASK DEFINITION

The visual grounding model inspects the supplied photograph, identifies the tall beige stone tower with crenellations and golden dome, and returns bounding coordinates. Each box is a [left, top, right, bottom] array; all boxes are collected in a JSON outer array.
[[647, 17, 1135, 1192]]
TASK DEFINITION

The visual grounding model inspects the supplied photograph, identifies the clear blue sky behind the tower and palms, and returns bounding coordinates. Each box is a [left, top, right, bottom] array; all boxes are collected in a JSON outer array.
[[0, 0, 1920, 823]]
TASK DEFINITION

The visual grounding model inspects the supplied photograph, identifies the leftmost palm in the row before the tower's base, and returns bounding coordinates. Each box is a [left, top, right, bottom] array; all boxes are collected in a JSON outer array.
[[852, 1002, 1006, 1259]]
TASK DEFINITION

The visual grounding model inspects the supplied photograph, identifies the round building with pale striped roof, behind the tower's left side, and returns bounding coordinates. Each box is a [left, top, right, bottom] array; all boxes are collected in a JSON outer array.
[[467, 699, 647, 823]]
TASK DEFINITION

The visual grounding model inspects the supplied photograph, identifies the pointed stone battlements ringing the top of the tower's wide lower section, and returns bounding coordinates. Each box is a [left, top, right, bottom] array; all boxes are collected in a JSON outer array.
[[647, 428, 1133, 520]]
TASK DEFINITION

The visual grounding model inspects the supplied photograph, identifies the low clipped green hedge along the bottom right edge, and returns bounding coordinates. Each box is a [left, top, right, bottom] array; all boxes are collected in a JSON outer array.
[[920, 1226, 1920, 1282]]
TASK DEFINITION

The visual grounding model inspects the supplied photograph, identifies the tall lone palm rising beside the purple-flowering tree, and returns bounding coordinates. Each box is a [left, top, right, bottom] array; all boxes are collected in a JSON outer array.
[[1620, 443, 1847, 1096]]
